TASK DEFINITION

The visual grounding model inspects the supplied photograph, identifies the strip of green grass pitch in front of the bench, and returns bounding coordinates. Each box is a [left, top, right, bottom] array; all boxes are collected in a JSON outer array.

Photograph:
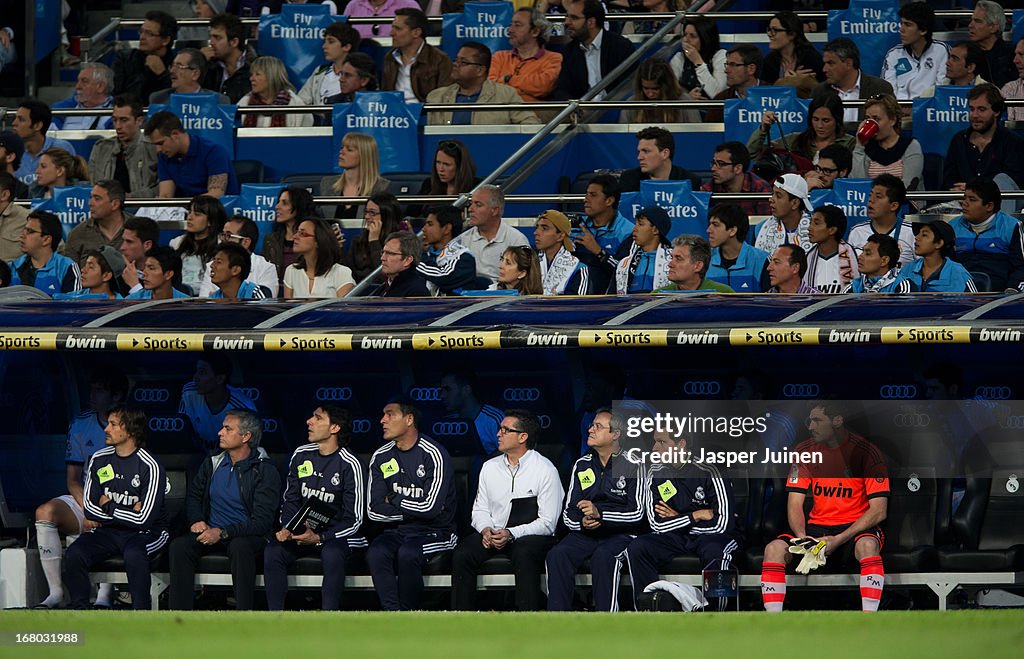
[[0, 611, 1024, 659]]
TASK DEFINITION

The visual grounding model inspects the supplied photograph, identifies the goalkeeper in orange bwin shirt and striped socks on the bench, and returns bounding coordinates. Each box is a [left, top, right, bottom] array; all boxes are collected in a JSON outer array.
[[761, 401, 889, 612]]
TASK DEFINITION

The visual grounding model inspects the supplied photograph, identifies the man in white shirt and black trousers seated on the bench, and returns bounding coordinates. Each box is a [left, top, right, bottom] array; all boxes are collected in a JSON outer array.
[[452, 409, 564, 611]]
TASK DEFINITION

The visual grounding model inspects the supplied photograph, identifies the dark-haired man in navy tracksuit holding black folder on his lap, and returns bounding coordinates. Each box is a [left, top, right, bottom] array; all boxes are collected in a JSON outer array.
[[263, 405, 367, 611]]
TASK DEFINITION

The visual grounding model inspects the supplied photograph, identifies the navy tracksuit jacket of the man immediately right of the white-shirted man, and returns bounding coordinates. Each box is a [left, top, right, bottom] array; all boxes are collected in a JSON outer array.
[[562, 450, 646, 536]]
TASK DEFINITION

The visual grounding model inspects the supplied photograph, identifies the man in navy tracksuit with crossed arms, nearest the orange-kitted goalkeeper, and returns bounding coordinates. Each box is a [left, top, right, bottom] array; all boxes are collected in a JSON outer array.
[[621, 433, 741, 611]]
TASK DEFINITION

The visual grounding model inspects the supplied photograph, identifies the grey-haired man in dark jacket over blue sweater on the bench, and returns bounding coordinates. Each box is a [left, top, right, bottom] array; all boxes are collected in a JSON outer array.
[[169, 409, 281, 611]]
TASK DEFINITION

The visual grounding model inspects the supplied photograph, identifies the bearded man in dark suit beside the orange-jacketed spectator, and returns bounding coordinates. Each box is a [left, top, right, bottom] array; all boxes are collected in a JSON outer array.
[[554, 0, 634, 100]]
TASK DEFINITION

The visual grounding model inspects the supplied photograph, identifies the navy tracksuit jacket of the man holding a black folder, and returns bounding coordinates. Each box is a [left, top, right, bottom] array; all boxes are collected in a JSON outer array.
[[281, 444, 367, 547]]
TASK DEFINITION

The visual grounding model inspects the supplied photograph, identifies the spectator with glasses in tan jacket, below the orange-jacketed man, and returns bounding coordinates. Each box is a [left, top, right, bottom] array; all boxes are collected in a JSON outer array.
[[427, 41, 541, 126]]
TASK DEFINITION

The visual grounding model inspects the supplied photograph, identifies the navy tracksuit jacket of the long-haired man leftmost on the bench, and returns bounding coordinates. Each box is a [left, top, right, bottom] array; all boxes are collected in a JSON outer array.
[[83, 446, 167, 533]]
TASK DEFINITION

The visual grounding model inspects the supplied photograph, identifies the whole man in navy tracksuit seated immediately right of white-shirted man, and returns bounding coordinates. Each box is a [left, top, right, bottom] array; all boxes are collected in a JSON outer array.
[[546, 408, 646, 611]]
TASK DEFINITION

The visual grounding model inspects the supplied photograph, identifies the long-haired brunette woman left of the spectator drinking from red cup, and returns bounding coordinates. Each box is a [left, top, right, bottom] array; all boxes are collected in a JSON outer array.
[[746, 94, 857, 163]]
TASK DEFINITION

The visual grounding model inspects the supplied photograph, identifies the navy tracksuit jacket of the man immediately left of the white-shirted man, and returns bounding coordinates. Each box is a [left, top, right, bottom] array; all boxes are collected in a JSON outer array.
[[367, 435, 456, 533]]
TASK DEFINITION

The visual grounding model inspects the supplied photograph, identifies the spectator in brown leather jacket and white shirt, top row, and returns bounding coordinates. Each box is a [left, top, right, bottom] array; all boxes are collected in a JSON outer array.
[[381, 8, 452, 103]]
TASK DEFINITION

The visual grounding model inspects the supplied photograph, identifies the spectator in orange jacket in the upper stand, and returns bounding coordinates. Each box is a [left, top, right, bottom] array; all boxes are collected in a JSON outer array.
[[488, 8, 562, 103]]
